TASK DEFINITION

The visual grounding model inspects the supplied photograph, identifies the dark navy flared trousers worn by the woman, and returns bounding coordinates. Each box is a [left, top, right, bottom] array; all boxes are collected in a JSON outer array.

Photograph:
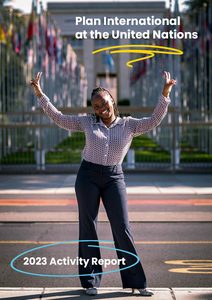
[[75, 160, 146, 288]]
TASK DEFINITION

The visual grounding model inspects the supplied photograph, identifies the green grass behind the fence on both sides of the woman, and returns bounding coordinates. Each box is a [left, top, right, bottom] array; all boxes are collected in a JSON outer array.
[[1, 133, 212, 165]]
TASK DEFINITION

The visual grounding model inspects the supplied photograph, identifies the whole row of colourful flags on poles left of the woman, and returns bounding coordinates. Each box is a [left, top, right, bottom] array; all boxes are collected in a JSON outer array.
[[0, 0, 87, 116]]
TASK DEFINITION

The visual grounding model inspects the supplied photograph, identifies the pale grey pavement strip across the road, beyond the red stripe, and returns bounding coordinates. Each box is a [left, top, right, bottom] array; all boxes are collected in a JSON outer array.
[[0, 173, 212, 195]]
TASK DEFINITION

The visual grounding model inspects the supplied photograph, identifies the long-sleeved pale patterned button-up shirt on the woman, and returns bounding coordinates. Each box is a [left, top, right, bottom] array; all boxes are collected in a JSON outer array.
[[39, 95, 171, 166]]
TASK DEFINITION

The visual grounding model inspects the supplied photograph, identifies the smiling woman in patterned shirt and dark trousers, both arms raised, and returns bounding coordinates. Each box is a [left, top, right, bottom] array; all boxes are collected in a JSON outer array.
[[31, 72, 176, 296]]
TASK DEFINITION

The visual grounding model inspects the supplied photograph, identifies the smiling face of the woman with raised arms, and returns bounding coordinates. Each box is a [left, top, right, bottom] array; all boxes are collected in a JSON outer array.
[[92, 92, 114, 120]]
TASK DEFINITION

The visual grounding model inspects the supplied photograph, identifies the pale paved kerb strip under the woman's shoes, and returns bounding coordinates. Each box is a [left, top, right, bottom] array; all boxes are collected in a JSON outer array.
[[0, 288, 212, 300]]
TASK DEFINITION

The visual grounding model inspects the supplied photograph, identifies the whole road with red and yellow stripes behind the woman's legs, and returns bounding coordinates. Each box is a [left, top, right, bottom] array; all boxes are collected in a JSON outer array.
[[0, 173, 212, 288]]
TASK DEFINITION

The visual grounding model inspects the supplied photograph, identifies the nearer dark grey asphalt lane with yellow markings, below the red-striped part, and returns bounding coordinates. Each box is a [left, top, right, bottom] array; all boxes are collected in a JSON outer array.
[[0, 223, 212, 287]]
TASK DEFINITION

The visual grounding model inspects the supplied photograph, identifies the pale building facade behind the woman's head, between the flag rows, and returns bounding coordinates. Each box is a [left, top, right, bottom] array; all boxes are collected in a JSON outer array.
[[47, 1, 166, 100]]
